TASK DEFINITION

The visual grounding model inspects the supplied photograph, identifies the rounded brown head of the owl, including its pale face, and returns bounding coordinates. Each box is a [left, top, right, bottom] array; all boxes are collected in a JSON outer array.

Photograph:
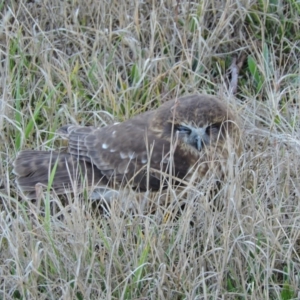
[[156, 95, 241, 155]]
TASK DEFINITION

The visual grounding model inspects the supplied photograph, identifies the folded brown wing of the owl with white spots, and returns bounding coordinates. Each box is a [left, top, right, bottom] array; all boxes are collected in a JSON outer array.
[[60, 113, 170, 190]]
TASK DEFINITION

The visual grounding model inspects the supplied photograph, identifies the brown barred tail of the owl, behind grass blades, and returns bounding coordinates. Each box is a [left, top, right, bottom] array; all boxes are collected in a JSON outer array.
[[13, 150, 103, 199]]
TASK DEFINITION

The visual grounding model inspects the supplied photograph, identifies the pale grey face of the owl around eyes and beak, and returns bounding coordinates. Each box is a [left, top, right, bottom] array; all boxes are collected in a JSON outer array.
[[175, 124, 220, 151]]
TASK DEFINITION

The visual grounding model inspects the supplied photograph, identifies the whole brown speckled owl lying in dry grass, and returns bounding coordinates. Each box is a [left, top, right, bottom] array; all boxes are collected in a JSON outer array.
[[14, 95, 241, 198]]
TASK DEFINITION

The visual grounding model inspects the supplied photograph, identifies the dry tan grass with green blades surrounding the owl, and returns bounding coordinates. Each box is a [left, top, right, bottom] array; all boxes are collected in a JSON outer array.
[[0, 0, 300, 300]]
